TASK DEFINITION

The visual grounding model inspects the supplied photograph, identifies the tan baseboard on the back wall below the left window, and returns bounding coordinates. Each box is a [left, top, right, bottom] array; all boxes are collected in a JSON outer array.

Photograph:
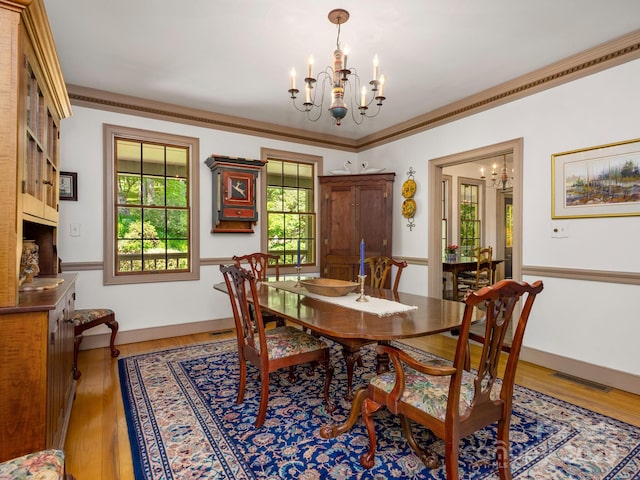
[[80, 318, 235, 350]]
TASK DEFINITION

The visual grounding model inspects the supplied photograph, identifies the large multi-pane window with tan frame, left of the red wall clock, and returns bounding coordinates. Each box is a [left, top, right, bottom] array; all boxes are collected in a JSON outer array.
[[104, 125, 200, 284]]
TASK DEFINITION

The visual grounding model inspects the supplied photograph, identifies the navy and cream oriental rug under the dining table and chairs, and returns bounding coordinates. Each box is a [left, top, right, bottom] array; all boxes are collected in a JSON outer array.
[[118, 339, 640, 480]]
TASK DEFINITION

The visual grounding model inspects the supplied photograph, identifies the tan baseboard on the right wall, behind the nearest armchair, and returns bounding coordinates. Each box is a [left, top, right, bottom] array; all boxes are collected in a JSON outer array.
[[520, 347, 640, 395]]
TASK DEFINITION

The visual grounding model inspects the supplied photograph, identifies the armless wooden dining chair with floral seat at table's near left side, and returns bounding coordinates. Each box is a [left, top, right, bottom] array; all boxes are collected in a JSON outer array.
[[220, 265, 335, 428]]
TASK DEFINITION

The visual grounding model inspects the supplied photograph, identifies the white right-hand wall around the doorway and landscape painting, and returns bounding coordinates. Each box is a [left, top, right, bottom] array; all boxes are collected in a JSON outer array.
[[360, 60, 640, 375]]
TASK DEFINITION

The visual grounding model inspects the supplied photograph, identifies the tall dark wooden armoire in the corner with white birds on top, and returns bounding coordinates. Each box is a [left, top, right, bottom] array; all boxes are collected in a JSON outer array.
[[319, 172, 395, 281]]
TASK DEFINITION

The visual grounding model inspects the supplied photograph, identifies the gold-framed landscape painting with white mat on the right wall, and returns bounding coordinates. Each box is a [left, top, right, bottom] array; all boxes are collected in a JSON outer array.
[[551, 139, 640, 218]]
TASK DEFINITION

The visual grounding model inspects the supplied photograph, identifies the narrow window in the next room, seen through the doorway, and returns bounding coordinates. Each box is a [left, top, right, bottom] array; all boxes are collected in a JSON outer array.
[[459, 178, 483, 257]]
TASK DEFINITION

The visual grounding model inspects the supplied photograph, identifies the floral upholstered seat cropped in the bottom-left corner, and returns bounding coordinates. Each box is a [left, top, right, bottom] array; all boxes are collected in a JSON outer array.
[[0, 450, 73, 480]]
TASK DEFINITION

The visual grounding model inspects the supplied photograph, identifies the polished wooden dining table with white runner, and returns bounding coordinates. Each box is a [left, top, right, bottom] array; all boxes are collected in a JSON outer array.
[[214, 280, 480, 400]]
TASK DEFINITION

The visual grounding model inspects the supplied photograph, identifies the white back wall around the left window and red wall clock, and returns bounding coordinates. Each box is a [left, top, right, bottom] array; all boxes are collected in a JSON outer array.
[[58, 106, 356, 335]]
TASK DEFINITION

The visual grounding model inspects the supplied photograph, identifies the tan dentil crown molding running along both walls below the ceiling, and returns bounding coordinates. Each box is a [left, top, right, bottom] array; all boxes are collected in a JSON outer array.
[[67, 30, 640, 152]]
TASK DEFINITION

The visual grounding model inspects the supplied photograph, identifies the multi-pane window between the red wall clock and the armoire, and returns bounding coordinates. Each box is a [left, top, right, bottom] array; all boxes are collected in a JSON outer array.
[[262, 150, 319, 267]]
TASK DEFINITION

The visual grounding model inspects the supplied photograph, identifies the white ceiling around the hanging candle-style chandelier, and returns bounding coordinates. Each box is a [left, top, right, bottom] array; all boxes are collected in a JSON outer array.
[[44, 0, 640, 139]]
